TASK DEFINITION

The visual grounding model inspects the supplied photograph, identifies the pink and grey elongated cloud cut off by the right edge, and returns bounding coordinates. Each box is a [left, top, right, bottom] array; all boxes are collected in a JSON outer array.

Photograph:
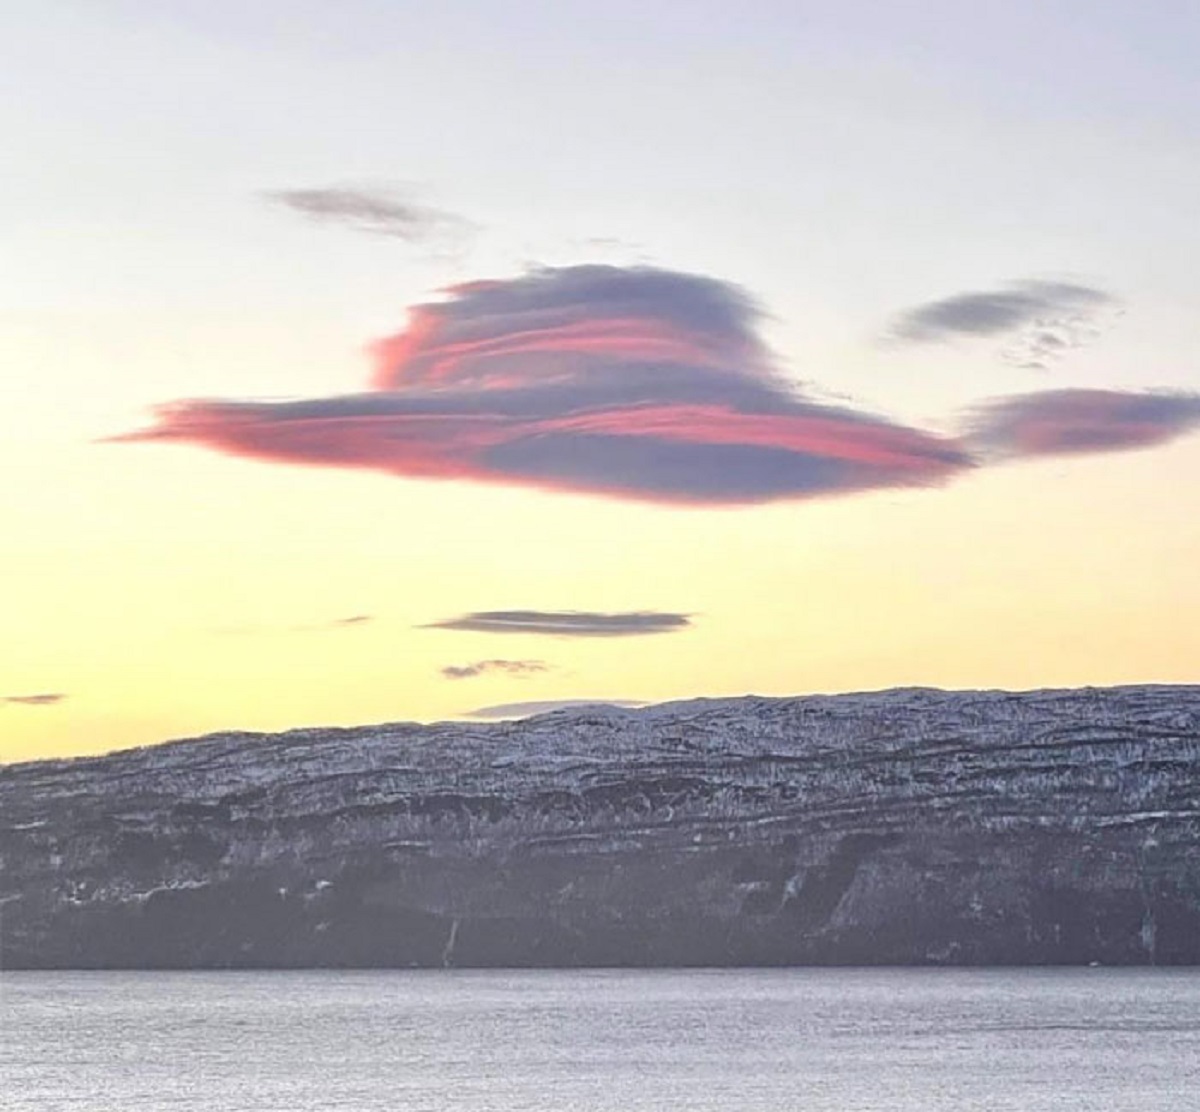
[[971, 390, 1200, 458]]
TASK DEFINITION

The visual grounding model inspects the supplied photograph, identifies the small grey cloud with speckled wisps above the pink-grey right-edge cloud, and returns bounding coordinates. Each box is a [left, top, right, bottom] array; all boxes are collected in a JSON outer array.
[[889, 279, 1120, 371]]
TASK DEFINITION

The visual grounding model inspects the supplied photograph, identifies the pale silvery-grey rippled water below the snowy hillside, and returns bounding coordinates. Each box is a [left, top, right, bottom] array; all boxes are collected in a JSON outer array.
[[0, 969, 1200, 1112]]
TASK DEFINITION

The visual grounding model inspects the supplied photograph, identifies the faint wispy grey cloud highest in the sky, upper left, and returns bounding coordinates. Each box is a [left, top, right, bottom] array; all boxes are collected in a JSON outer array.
[[264, 186, 469, 244]]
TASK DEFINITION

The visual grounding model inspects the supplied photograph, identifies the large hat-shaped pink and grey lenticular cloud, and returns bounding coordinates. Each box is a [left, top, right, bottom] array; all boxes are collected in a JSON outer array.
[[118, 265, 972, 505]]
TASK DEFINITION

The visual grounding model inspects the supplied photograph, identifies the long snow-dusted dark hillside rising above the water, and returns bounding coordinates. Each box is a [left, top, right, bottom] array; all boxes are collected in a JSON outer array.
[[0, 687, 1200, 968]]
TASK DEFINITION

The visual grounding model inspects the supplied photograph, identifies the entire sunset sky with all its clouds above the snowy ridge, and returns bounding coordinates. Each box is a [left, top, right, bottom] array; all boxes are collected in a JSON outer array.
[[0, 0, 1200, 762]]
